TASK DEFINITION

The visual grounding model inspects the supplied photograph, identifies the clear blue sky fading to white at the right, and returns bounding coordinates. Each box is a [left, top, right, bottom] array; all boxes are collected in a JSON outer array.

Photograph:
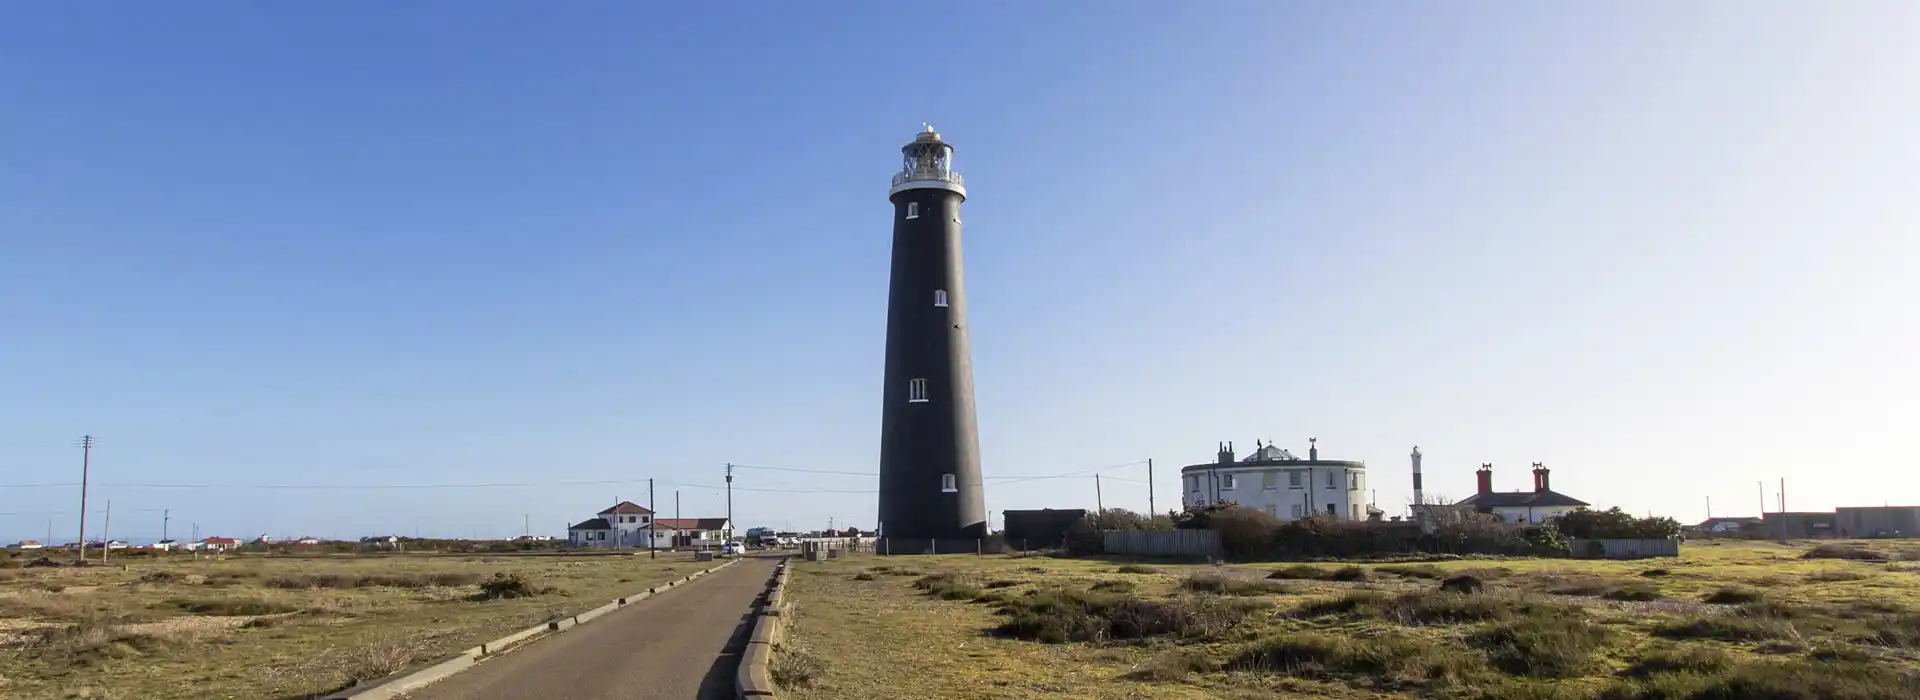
[[0, 2, 1920, 541]]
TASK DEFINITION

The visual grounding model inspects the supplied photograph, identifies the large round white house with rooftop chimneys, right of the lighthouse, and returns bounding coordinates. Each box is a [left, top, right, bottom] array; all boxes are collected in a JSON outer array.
[[1181, 443, 1369, 520]]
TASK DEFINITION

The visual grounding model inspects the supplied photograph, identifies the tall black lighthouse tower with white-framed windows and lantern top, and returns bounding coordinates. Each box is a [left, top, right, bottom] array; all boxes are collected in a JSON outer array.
[[879, 127, 987, 541]]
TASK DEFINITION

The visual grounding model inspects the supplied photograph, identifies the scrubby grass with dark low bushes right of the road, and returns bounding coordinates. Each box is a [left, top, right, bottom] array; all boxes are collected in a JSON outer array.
[[771, 543, 1920, 700]]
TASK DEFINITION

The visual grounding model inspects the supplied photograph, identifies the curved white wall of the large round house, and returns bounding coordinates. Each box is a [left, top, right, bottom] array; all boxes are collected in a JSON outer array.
[[1181, 464, 1367, 520]]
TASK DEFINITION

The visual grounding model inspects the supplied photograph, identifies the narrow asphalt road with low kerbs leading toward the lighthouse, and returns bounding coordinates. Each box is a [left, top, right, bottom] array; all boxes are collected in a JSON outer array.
[[405, 558, 776, 700]]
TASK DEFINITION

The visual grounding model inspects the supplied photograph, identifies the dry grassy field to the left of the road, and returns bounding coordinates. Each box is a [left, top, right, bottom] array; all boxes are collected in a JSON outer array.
[[0, 554, 705, 700]]
